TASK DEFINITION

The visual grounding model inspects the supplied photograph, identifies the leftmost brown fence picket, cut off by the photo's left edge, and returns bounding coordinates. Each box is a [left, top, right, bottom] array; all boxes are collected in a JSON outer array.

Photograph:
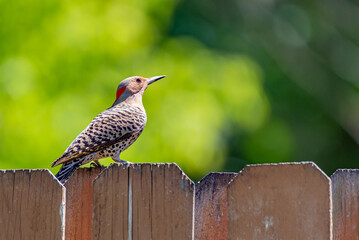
[[0, 169, 65, 240]]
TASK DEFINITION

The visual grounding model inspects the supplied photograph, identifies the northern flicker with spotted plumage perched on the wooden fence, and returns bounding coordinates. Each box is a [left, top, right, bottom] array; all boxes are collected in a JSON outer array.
[[52, 76, 165, 183]]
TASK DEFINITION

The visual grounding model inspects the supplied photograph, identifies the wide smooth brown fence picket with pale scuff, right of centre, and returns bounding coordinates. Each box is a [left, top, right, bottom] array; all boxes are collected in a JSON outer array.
[[228, 163, 332, 240]]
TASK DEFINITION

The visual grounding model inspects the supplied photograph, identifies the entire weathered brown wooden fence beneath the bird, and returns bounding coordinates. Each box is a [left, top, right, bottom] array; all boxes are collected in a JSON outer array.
[[0, 162, 359, 240]]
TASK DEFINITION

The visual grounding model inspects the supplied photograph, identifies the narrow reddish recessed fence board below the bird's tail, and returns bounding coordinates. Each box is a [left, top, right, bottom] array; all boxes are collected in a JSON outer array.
[[65, 167, 105, 240]]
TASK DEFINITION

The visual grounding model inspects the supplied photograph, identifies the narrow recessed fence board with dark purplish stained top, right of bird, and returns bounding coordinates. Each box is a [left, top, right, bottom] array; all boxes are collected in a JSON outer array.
[[194, 173, 237, 240]]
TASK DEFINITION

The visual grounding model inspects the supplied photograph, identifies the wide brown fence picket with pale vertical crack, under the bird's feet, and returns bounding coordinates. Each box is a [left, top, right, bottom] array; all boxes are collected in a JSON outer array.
[[92, 164, 194, 240]]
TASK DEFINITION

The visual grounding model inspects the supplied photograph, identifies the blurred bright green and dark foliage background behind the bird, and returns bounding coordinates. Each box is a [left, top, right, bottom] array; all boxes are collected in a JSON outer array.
[[0, 0, 359, 180]]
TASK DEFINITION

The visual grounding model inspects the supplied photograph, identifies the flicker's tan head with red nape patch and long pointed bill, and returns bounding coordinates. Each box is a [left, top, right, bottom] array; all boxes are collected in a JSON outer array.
[[113, 75, 165, 105]]
